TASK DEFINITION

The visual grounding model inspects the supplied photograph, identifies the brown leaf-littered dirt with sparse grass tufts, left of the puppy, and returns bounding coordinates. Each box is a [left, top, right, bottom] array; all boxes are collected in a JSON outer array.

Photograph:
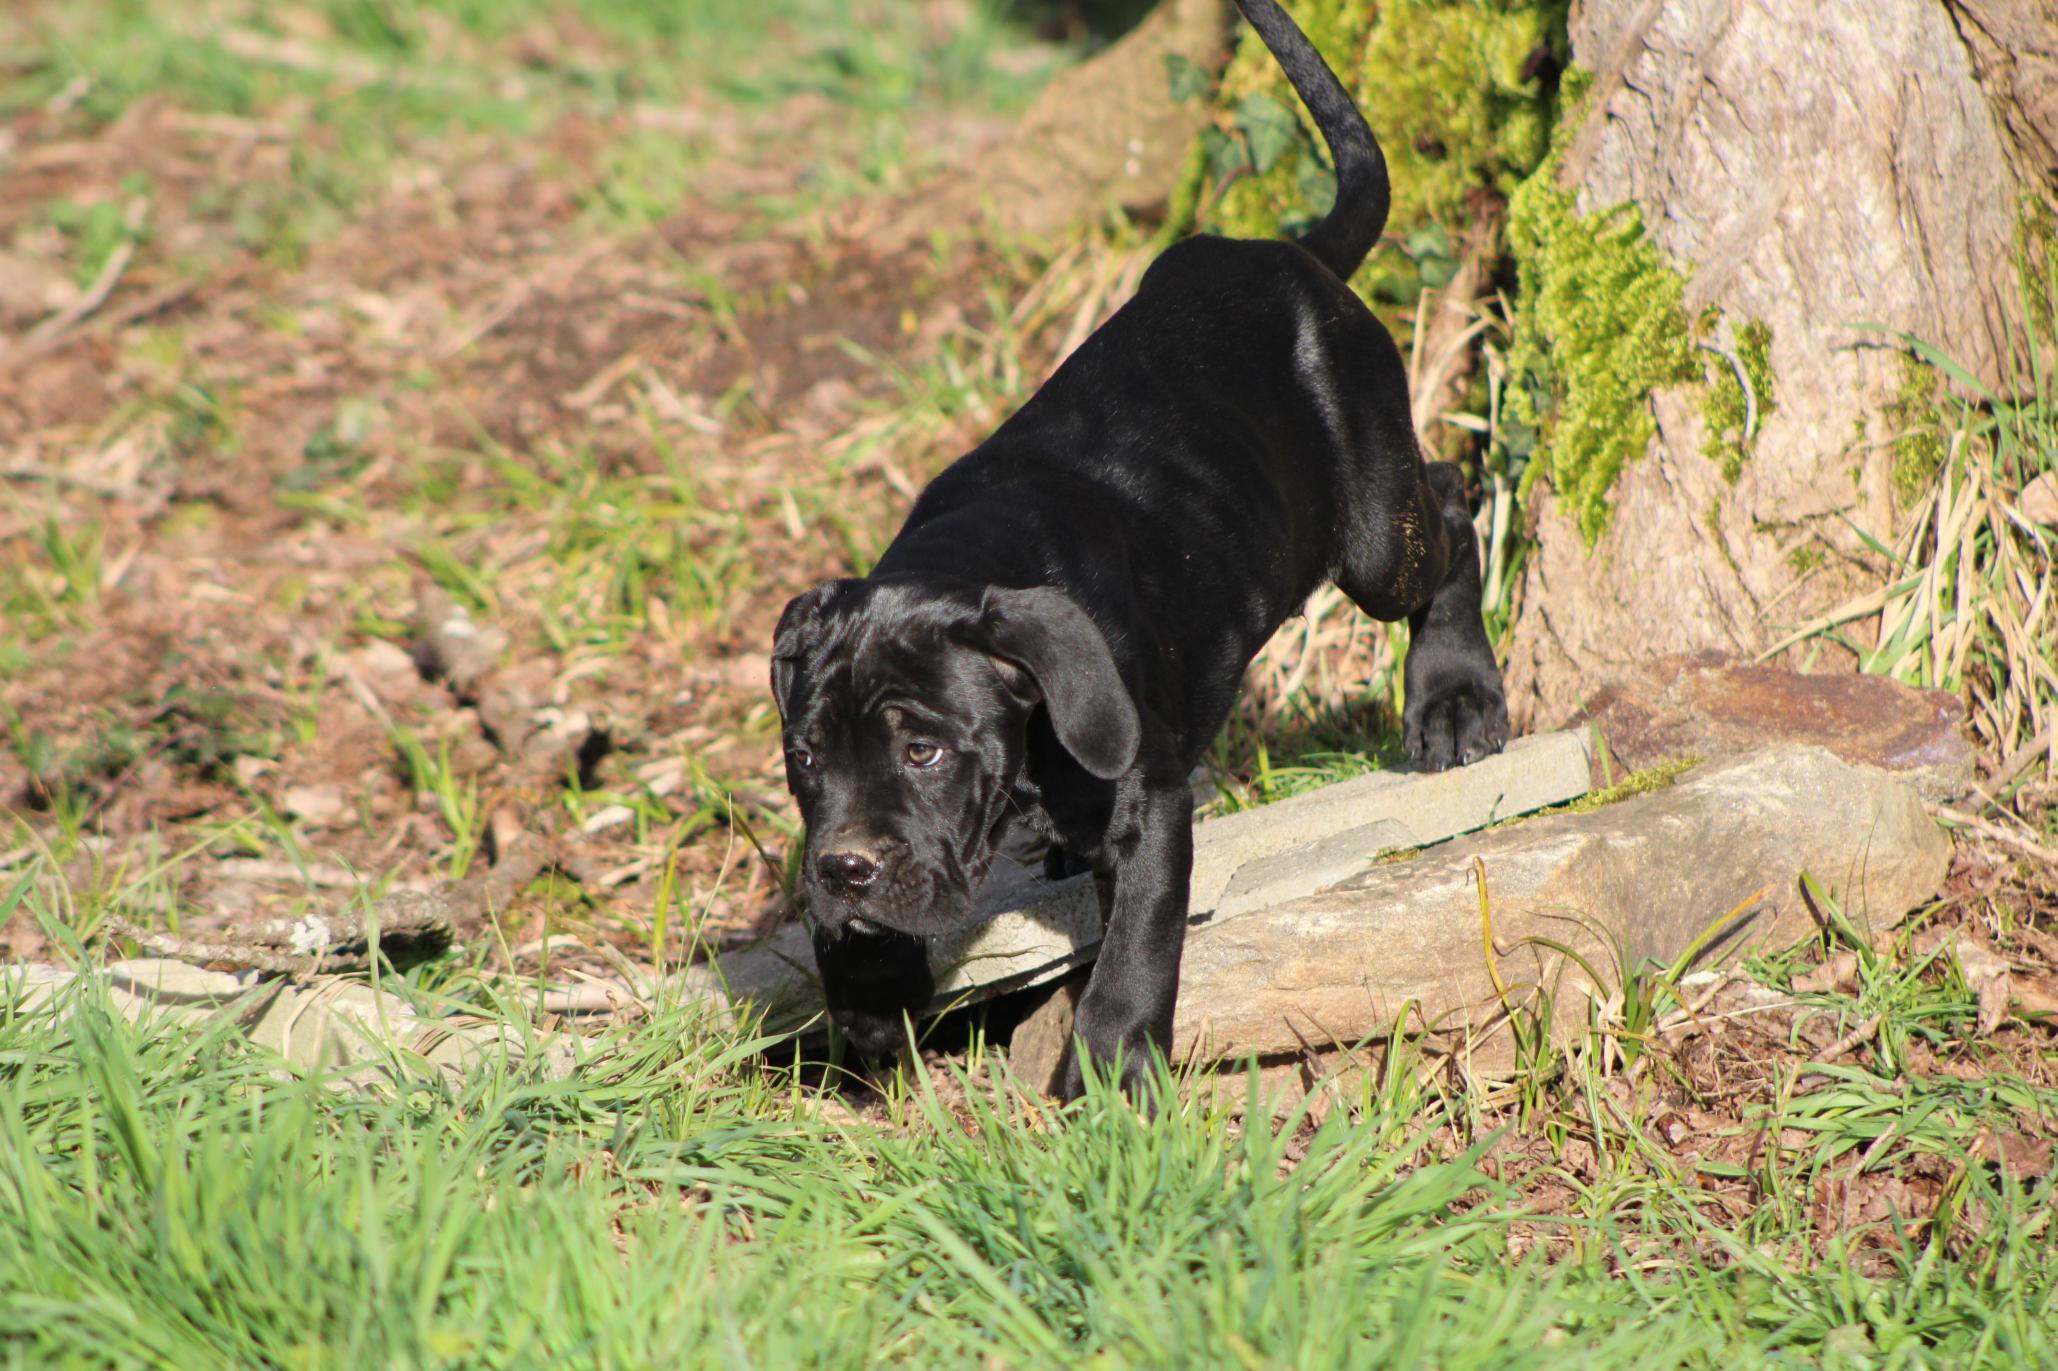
[[0, 10, 1070, 975]]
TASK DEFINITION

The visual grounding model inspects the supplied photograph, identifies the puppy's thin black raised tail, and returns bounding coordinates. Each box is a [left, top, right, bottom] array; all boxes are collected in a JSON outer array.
[[1237, 0, 1391, 278]]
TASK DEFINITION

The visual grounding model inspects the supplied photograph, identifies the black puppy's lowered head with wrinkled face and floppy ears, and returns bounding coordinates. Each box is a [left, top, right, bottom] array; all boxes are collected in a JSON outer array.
[[772, 576, 1138, 935]]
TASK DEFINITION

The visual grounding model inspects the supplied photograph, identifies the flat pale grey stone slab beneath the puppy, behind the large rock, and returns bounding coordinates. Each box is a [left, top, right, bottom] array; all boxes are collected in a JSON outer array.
[[681, 731, 1591, 1025]]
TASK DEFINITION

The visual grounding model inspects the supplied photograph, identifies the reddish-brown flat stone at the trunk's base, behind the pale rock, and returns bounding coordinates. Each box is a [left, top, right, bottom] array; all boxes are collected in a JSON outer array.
[[1585, 653, 1974, 801]]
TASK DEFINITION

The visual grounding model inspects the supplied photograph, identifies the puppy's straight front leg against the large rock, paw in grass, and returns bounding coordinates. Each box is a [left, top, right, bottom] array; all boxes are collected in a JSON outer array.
[[1060, 747, 1194, 1103]]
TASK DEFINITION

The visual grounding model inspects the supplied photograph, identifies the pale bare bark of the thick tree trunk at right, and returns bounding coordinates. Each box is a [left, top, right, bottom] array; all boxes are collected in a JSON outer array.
[[1509, 0, 2058, 725]]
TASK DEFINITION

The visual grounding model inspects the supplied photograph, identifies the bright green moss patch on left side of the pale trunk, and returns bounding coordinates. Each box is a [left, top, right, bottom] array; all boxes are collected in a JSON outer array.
[[1509, 138, 1700, 546]]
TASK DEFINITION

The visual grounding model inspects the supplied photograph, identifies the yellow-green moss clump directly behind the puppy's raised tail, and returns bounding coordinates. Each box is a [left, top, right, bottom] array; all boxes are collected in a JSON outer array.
[[1190, 0, 1566, 314]]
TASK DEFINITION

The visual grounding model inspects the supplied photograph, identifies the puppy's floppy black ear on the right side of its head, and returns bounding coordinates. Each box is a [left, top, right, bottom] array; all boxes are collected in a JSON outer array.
[[978, 587, 1142, 780]]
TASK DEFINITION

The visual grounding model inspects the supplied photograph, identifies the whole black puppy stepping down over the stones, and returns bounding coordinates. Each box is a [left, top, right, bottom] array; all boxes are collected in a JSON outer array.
[[772, 0, 1509, 1097]]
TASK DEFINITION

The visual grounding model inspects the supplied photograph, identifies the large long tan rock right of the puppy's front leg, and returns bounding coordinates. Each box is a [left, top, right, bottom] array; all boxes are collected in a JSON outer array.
[[1173, 747, 1951, 1066]]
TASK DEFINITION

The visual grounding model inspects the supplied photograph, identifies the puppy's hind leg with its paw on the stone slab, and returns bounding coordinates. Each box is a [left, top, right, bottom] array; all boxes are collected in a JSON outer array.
[[1336, 452, 1509, 772]]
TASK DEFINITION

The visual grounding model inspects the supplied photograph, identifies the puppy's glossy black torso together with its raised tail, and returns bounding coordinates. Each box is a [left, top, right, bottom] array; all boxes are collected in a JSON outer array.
[[875, 0, 1420, 755]]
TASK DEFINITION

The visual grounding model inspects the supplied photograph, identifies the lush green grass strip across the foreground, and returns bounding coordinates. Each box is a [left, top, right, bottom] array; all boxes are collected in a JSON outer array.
[[0, 938, 2058, 1369]]
